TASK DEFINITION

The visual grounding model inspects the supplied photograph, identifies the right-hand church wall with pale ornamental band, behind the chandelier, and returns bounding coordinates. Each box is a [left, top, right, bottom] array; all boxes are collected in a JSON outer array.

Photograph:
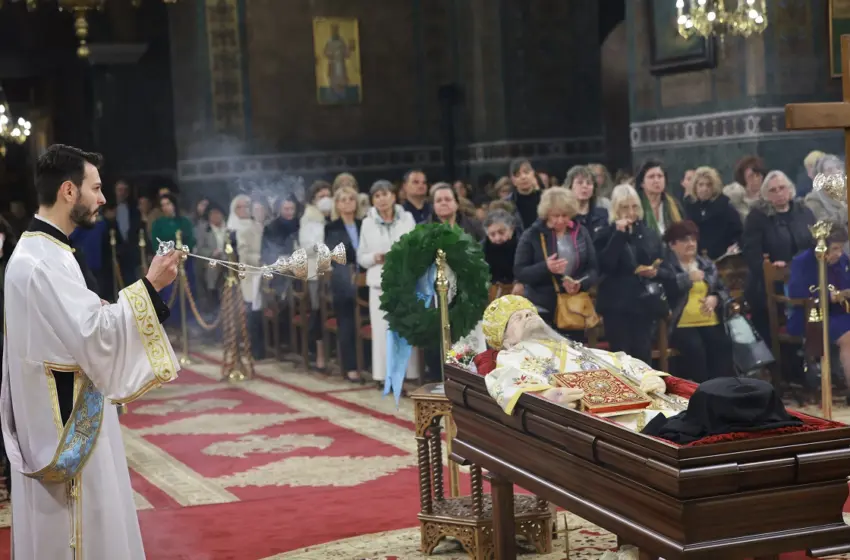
[[626, 0, 841, 190]]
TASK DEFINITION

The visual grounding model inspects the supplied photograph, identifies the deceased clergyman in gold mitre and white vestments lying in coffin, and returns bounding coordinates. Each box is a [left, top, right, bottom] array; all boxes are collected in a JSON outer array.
[[483, 295, 667, 414]]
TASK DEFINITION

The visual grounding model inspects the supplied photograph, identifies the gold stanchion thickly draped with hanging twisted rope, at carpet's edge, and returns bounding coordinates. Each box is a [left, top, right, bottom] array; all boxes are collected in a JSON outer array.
[[220, 242, 254, 382]]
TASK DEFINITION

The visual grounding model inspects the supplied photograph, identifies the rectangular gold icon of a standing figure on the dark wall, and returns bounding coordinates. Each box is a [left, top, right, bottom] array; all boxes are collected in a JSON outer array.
[[313, 17, 363, 105]]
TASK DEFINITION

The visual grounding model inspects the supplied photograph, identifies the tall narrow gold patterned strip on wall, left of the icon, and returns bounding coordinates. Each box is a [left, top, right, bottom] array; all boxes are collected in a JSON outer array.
[[206, 0, 245, 138]]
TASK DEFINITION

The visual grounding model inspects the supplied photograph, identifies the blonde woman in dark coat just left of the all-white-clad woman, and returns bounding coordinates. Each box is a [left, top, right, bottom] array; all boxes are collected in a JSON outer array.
[[325, 186, 361, 383]]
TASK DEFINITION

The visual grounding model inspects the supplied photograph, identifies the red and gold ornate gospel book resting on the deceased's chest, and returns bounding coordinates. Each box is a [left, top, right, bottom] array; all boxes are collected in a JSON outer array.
[[552, 369, 652, 413]]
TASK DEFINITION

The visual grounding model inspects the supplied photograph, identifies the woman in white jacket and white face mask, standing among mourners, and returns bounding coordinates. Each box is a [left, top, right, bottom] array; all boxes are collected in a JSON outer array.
[[298, 181, 334, 373]]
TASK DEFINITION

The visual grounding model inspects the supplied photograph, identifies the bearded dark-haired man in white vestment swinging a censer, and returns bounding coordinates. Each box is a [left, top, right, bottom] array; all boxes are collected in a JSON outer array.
[[0, 146, 180, 560]]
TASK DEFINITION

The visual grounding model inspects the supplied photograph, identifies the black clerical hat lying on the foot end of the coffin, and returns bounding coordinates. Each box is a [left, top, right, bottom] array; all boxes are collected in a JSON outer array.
[[642, 377, 803, 445]]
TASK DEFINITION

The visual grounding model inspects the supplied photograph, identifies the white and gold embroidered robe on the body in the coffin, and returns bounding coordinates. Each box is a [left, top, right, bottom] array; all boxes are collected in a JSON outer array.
[[485, 340, 667, 414]]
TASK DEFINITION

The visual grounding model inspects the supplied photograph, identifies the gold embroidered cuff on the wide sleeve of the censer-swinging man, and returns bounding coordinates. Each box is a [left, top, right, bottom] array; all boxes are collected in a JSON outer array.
[[122, 280, 177, 384]]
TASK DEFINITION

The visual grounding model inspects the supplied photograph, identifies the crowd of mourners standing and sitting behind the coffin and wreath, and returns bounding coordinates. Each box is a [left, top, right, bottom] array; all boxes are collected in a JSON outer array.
[[0, 152, 850, 402]]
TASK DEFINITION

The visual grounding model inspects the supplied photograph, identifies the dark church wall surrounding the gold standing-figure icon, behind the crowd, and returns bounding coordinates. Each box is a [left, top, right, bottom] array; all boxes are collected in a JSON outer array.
[[172, 0, 604, 200]]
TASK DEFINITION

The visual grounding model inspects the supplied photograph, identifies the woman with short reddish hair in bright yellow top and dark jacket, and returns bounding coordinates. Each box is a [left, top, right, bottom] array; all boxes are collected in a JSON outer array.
[[660, 218, 738, 383]]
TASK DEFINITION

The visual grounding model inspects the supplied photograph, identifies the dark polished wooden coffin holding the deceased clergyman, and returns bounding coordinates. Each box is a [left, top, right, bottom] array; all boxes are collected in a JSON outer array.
[[446, 365, 850, 560]]
